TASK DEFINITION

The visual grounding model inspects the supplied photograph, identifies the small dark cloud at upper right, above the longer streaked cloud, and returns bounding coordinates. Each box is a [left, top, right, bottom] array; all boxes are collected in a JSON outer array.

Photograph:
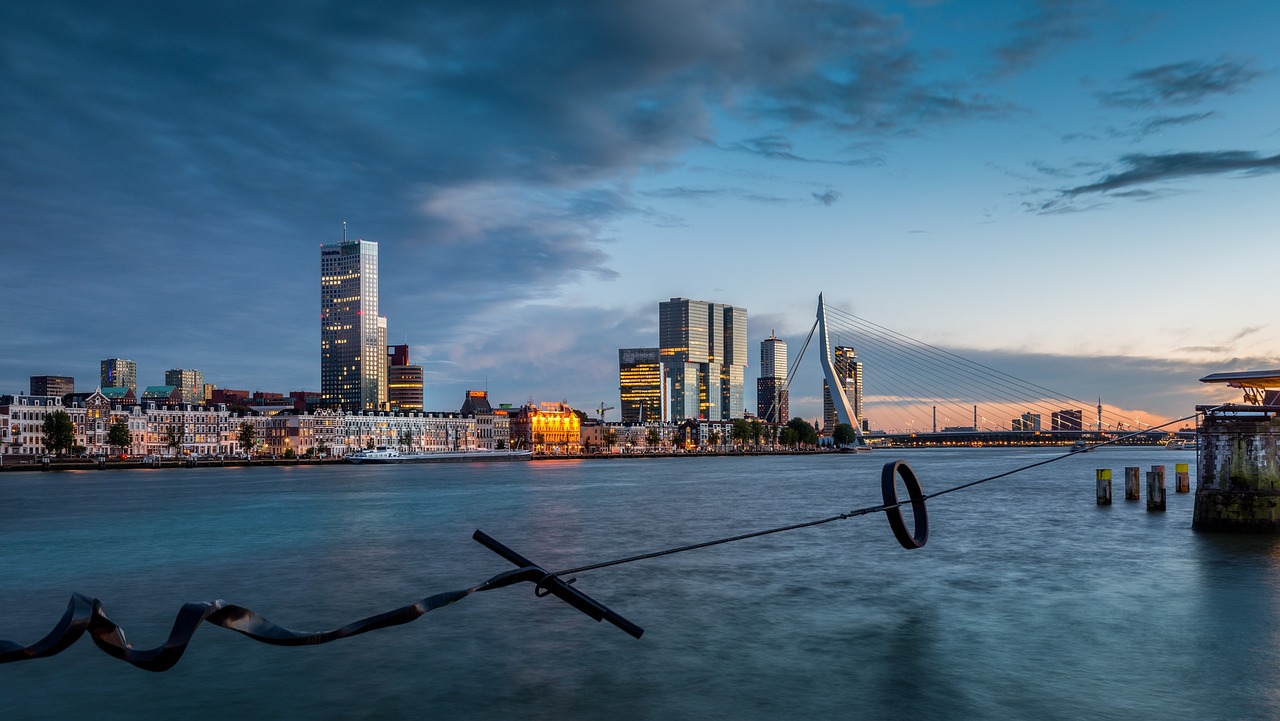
[[1097, 58, 1262, 108]]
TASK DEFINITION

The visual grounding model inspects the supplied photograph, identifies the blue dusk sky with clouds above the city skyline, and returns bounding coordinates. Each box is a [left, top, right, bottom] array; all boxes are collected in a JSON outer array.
[[0, 0, 1280, 420]]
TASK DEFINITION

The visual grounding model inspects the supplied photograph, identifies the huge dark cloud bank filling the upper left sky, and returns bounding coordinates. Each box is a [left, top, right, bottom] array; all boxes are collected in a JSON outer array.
[[0, 0, 1010, 394]]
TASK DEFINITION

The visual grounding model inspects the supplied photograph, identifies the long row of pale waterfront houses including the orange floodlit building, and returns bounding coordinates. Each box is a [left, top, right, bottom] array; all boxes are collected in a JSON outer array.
[[0, 388, 752, 457]]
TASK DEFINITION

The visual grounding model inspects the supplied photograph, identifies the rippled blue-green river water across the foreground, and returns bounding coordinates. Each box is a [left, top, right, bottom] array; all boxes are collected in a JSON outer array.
[[0, 448, 1280, 721]]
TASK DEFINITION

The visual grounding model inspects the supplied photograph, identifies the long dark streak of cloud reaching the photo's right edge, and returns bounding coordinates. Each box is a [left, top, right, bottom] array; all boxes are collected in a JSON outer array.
[[1024, 150, 1280, 213]]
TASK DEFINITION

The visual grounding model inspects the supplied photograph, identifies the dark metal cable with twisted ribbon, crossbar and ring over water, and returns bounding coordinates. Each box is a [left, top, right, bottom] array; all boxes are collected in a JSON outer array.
[[0, 414, 1198, 671]]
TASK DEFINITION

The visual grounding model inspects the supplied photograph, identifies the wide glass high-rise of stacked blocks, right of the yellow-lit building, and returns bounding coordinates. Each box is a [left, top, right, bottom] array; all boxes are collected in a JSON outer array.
[[658, 298, 746, 421]]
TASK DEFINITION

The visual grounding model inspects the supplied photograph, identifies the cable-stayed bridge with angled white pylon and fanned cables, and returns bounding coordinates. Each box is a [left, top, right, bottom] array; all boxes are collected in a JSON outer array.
[[787, 295, 1192, 446]]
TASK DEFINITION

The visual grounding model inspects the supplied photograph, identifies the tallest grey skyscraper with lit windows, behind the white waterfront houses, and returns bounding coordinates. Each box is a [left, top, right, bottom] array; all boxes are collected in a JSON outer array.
[[320, 239, 387, 412]]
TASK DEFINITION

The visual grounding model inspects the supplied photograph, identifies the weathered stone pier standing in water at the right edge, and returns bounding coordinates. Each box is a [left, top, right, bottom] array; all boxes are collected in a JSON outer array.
[[1192, 406, 1280, 533]]
